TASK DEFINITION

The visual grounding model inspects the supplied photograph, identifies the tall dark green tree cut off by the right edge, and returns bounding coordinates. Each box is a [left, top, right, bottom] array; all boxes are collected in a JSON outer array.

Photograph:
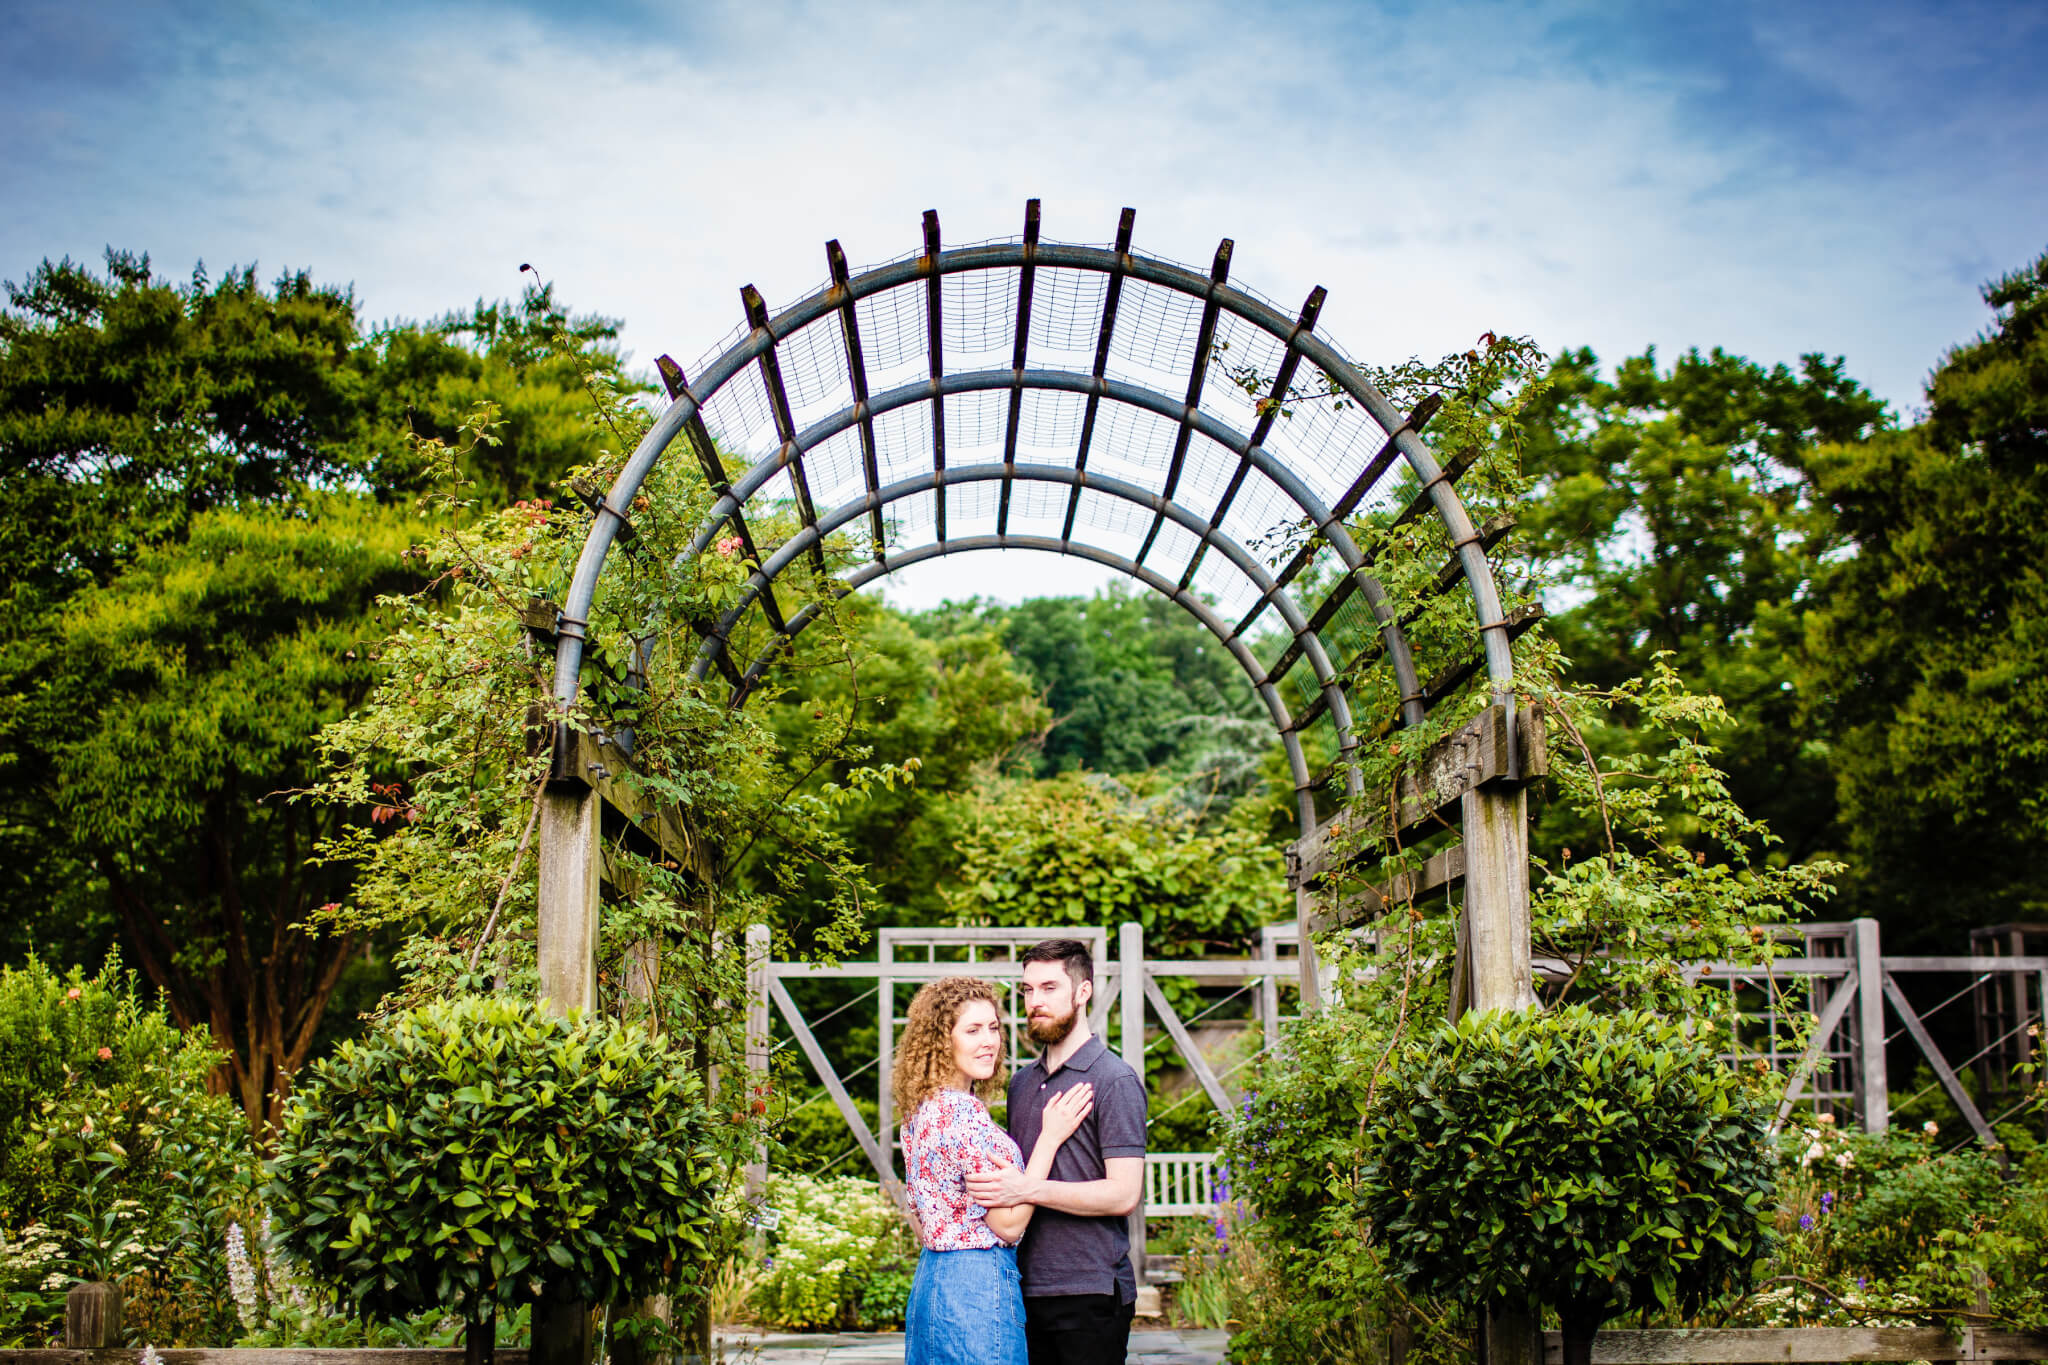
[[1798, 254, 2048, 941]]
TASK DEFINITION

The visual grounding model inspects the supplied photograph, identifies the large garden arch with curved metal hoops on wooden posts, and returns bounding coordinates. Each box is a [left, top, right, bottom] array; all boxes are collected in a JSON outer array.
[[541, 201, 1542, 1005]]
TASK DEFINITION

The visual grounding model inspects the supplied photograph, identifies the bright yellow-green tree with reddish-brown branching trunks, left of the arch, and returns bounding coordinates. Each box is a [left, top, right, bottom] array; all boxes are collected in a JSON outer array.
[[39, 497, 416, 1128]]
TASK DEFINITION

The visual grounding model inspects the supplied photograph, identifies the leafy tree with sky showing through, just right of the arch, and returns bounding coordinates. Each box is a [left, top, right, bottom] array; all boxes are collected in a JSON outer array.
[[1516, 348, 1886, 871]]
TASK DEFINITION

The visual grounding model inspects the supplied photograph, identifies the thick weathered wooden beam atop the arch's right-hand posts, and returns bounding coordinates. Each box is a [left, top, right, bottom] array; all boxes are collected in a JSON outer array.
[[1288, 706, 1548, 888]]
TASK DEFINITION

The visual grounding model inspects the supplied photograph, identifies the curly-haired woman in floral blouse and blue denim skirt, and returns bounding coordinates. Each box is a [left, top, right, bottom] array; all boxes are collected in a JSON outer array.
[[893, 976, 1096, 1365]]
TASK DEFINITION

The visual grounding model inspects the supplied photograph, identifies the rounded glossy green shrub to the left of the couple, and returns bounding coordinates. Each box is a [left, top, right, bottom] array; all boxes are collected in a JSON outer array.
[[268, 997, 719, 1351]]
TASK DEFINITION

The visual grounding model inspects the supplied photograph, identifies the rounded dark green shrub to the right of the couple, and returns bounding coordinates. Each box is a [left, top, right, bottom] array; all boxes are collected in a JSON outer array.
[[1360, 1007, 1774, 1365]]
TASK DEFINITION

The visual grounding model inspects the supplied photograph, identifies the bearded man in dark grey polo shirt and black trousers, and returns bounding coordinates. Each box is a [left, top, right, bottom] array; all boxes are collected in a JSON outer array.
[[967, 939, 1145, 1365]]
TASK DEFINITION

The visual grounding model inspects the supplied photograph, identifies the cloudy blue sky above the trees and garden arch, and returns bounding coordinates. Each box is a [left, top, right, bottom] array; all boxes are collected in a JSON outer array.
[[0, 0, 2048, 602]]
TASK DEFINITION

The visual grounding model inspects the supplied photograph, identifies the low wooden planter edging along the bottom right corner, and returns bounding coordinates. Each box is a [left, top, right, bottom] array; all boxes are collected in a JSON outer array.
[[1542, 1326, 2048, 1365]]
